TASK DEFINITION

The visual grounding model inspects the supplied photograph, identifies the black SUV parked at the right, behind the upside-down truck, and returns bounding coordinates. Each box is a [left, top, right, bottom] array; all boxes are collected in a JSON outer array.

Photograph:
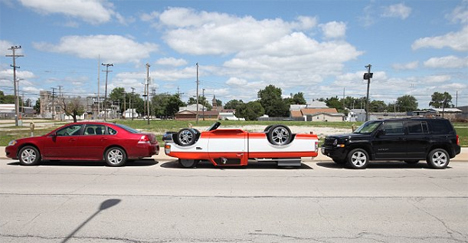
[[322, 118, 460, 169]]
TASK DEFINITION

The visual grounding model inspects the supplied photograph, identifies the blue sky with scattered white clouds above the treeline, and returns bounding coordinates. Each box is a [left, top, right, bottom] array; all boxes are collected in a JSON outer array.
[[0, 0, 468, 108]]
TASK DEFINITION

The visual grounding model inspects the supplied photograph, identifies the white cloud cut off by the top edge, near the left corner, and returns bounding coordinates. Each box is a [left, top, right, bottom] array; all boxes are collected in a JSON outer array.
[[19, 0, 115, 24]]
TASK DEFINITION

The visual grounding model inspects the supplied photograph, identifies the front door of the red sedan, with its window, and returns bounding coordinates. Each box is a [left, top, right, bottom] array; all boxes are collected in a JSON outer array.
[[41, 124, 83, 159]]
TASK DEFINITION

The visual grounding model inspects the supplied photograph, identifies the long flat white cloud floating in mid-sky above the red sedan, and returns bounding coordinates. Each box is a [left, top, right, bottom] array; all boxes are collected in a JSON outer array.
[[33, 35, 158, 63]]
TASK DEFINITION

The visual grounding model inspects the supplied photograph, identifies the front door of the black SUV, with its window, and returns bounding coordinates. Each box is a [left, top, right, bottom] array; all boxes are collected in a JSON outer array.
[[373, 120, 406, 159]]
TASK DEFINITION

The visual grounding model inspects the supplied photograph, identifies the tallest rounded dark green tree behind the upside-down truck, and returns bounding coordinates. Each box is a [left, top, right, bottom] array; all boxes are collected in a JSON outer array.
[[258, 85, 289, 117]]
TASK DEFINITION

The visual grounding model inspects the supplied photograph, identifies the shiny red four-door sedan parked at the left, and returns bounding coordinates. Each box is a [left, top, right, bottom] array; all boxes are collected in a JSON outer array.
[[5, 122, 159, 166]]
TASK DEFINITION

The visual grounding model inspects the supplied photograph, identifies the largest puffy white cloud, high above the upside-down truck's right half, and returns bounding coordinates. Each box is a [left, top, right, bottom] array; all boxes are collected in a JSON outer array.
[[223, 32, 362, 87]]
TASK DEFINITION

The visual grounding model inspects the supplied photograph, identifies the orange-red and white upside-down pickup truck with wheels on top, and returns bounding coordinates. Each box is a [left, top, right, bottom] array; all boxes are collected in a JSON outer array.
[[163, 122, 318, 168]]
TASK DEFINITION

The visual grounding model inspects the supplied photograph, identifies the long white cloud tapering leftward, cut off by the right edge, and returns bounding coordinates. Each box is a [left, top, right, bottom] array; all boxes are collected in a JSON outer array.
[[411, 26, 468, 51]]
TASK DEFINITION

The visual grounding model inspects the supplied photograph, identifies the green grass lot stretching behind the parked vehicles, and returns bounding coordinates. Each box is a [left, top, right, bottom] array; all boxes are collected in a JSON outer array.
[[0, 120, 468, 147]]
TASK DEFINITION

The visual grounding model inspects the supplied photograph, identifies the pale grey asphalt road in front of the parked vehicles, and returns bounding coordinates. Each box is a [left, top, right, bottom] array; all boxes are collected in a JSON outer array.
[[0, 159, 468, 243]]
